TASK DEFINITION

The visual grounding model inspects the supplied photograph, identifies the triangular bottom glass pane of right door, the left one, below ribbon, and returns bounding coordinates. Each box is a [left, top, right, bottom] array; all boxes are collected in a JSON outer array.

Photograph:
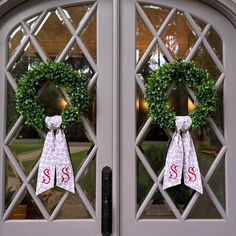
[[141, 191, 176, 219]]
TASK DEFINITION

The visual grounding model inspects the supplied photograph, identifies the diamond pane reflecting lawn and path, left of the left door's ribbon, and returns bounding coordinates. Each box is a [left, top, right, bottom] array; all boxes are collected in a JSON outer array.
[[10, 125, 44, 174]]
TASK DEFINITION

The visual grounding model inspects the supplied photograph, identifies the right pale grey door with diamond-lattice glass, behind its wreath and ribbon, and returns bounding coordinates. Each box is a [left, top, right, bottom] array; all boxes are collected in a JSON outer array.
[[120, 0, 236, 236]]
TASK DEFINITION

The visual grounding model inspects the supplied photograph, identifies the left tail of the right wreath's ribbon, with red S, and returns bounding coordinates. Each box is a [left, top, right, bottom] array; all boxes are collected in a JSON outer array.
[[163, 132, 183, 189]]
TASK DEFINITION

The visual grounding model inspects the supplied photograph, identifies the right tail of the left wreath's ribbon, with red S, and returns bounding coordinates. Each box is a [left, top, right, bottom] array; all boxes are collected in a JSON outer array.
[[56, 130, 75, 193]]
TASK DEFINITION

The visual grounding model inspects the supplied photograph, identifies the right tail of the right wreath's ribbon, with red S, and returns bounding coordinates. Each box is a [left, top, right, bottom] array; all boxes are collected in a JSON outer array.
[[183, 132, 203, 194]]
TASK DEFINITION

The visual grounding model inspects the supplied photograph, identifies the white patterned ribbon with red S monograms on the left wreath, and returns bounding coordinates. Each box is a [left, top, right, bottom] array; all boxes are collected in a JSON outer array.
[[36, 116, 75, 195]]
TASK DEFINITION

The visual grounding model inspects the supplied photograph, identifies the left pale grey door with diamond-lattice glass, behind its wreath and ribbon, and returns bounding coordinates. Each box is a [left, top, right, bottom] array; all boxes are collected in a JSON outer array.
[[0, 0, 113, 236]]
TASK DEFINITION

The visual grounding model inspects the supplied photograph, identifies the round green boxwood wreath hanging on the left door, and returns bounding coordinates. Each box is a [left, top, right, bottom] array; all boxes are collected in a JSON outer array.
[[16, 62, 90, 129]]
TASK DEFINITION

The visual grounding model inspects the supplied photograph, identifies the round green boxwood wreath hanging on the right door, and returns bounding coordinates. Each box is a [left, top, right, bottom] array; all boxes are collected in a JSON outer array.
[[145, 61, 217, 129]]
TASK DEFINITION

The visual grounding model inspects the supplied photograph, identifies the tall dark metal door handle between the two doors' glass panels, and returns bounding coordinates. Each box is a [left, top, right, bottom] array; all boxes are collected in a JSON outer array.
[[101, 166, 112, 236]]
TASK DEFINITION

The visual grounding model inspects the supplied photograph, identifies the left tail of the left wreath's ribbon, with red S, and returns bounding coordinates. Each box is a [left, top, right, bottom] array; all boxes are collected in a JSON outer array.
[[36, 131, 55, 195]]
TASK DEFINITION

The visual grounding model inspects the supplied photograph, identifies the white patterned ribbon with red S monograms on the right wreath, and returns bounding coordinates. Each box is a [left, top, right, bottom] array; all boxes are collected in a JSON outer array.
[[163, 116, 203, 194]]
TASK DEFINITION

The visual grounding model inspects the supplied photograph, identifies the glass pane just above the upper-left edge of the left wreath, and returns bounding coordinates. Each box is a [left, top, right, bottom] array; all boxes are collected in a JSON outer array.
[[10, 42, 42, 81]]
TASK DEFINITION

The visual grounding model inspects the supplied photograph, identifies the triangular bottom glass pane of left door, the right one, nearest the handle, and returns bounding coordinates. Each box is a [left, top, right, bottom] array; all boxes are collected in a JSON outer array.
[[57, 193, 92, 219]]
